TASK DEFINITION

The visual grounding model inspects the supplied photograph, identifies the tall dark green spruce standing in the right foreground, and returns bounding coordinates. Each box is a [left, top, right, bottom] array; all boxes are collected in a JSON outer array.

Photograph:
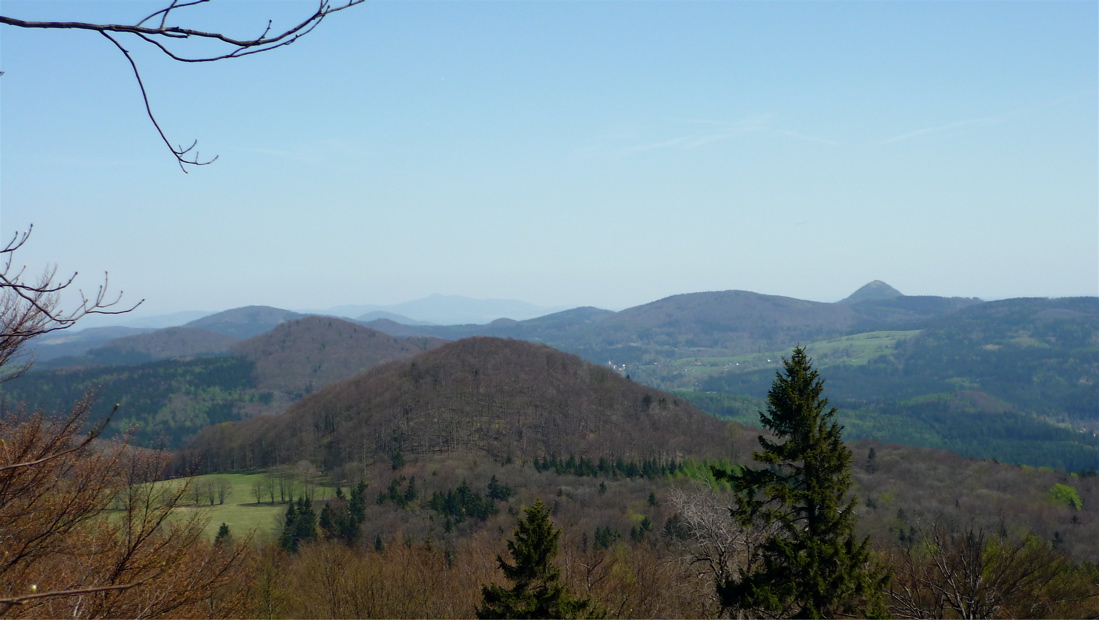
[[714, 347, 888, 618]]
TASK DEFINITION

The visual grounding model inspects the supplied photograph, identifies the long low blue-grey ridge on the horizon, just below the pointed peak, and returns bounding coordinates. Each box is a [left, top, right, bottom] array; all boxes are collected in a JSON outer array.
[[368, 285, 980, 376]]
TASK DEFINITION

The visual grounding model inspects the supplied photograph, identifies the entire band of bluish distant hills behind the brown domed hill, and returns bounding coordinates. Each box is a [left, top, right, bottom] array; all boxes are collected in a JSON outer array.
[[2, 283, 1099, 468]]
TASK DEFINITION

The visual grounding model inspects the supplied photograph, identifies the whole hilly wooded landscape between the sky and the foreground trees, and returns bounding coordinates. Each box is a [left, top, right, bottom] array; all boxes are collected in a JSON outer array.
[[0, 285, 1099, 617]]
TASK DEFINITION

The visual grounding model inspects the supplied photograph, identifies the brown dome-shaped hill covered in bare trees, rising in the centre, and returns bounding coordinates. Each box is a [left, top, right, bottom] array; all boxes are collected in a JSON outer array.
[[186, 337, 729, 470]]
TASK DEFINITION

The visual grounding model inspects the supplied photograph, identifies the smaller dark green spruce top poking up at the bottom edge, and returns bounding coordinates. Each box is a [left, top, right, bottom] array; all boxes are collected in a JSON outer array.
[[477, 499, 598, 618]]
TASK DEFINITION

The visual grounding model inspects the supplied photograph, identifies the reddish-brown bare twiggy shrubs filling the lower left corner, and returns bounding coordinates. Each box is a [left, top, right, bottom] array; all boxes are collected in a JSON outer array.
[[0, 398, 248, 618]]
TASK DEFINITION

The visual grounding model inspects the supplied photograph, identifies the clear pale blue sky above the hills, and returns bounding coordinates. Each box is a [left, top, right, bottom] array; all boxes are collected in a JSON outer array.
[[0, 0, 1099, 315]]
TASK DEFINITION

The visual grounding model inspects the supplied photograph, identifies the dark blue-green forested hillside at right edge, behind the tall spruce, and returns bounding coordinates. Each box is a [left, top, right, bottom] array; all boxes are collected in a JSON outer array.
[[691, 298, 1099, 470]]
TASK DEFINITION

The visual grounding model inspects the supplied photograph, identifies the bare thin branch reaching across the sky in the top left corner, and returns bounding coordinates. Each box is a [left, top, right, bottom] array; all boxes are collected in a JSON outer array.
[[0, 0, 365, 173]]
